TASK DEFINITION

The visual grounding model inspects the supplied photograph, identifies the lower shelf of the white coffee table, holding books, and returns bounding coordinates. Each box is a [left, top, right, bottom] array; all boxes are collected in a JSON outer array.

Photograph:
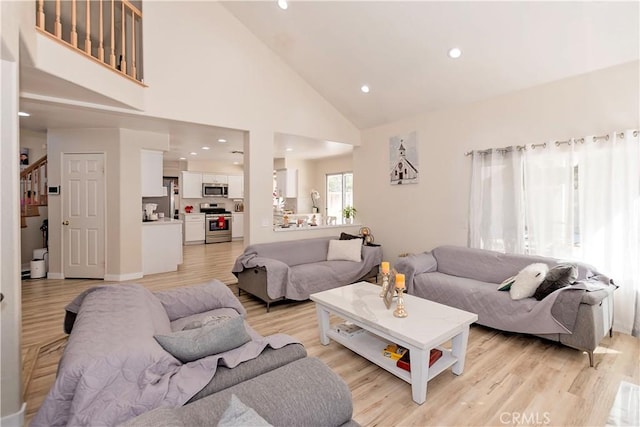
[[327, 328, 458, 384]]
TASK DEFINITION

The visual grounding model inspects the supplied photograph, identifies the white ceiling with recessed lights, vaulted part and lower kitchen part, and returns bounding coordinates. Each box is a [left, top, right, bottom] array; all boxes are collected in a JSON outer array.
[[20, 1, 640, 162]]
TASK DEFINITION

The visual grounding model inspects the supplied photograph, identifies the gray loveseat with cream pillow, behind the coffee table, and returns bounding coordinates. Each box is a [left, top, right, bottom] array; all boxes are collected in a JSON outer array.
[[232, 234, 382, 311]]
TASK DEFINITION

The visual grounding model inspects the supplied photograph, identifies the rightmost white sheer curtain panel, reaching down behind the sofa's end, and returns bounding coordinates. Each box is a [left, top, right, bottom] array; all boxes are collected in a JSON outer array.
[[576, 130, 640, 336]]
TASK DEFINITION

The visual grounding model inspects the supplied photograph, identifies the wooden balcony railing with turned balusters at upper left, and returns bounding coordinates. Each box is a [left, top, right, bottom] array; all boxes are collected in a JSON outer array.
[[35, 0, 143, 83]]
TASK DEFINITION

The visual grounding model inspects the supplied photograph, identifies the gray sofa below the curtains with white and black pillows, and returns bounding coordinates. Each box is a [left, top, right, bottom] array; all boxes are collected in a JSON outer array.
[[395, 246, 616, 366]]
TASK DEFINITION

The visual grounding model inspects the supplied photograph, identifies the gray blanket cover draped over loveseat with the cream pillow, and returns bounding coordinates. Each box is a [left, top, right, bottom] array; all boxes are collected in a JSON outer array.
[[231, 239, 382, 301]]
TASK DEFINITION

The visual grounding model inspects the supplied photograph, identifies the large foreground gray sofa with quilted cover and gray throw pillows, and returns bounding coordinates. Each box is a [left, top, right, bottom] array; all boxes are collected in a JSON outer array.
[[31, 280, 357, 427]]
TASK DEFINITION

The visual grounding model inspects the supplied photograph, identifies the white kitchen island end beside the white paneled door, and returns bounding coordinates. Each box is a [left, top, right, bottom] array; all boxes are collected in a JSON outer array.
[[142, 218, 182, 276]]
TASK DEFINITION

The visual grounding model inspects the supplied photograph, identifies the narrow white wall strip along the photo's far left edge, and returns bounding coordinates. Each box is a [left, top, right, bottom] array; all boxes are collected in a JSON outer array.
[[0, 2, 25, 427]]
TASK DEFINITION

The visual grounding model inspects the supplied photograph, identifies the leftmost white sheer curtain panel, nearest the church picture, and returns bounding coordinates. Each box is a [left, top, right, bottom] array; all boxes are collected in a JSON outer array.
[[469, 147, 524, 253]]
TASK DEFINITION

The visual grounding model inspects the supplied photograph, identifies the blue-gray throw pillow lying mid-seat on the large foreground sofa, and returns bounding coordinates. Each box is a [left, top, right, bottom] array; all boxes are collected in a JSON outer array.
[[154, 316, 251, 363]]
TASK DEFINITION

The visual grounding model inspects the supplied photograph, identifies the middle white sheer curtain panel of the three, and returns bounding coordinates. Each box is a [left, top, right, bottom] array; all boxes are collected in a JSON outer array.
[[524, 141, 577, 258]]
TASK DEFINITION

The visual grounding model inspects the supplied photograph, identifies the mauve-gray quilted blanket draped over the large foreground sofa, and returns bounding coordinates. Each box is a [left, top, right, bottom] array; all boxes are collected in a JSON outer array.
[[31, 284, 297, 427]]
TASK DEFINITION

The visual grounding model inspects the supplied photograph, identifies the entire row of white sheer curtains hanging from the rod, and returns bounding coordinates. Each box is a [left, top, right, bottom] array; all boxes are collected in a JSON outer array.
[[469, 130, 640, 336]]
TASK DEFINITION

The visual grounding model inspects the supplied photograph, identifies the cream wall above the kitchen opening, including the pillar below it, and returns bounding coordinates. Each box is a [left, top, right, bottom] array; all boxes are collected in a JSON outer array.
[[144, 2, 360, 243]]
